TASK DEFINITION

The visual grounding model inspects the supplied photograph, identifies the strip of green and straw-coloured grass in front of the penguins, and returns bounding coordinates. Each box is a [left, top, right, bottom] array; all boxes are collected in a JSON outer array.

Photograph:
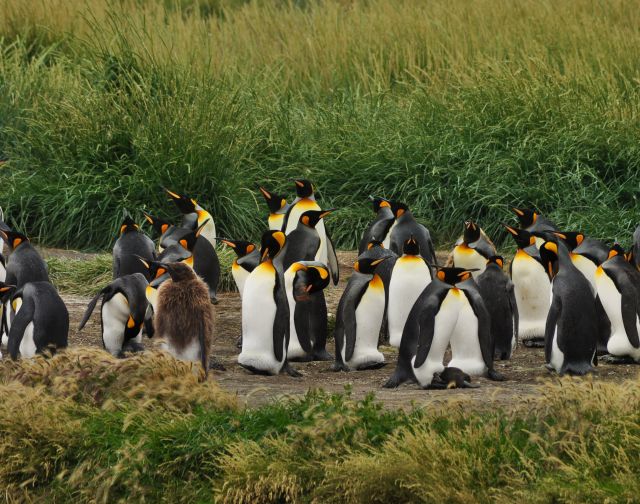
[[0, 350, 640, 503]]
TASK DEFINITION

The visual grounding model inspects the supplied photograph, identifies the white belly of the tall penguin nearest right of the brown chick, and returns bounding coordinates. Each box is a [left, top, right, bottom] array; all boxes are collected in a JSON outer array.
[[238, 262, 287, 375]]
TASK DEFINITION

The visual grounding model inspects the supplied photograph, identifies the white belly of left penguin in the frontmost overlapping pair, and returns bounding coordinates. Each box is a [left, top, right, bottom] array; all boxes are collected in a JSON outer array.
[[411, 289, 462, 387]]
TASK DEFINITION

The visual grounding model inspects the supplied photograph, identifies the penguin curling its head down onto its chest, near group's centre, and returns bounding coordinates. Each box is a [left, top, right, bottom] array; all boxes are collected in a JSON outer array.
[[284, 261, 333, 361]]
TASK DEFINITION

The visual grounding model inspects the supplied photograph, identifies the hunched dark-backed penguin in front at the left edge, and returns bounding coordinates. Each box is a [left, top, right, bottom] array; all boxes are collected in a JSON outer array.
[[0, 282, 69, 360]]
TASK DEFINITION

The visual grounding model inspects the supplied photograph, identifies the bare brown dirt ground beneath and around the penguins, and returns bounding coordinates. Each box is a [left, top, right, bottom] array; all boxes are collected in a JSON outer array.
[[56, 252, 640, 408]]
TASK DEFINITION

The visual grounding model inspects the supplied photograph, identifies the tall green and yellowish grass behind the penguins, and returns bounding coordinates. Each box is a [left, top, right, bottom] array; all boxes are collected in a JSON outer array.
[[0, 0, 640, 249]]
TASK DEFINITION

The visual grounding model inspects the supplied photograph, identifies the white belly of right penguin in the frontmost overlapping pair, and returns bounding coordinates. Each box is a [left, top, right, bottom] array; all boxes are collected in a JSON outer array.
[[448, 291, 487, 376]]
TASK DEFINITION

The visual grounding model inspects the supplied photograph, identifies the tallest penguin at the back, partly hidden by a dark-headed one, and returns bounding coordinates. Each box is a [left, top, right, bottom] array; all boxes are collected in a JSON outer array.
[[282, 179, 340, 285]]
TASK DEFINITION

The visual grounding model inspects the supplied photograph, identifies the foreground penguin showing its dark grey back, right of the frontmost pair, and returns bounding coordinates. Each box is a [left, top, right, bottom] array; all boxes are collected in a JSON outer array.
[[540, 241, 598, 375]]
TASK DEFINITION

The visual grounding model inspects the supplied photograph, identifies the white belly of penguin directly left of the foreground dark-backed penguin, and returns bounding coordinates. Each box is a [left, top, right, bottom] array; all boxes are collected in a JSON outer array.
[[511, 251, 551, 340]]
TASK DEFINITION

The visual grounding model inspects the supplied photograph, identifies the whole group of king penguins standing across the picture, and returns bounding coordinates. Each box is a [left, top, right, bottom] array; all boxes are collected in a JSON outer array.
[[0, 184, 640, 389]]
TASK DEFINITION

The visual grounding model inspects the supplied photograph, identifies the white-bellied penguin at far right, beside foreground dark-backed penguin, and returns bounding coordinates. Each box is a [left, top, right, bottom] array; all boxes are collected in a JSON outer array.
[[595, 244, 640, 364]]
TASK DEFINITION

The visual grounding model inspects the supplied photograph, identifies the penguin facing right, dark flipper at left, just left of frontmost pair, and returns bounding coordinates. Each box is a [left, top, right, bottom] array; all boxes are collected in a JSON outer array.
[[333, 247, 391, 371]]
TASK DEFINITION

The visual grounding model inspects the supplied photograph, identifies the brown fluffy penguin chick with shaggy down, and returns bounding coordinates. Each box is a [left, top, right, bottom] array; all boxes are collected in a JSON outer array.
[[153, 263, 214, 377]]
